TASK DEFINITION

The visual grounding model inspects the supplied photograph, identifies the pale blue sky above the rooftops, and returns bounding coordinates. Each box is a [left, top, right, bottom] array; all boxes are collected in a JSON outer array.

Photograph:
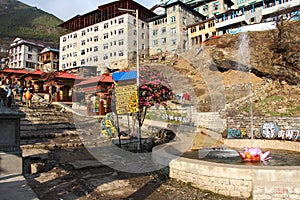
[[19, 0, 160, 21]]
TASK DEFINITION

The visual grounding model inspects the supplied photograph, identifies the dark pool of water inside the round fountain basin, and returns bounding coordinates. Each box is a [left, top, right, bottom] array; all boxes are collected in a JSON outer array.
[[182, 149, 300, 166]]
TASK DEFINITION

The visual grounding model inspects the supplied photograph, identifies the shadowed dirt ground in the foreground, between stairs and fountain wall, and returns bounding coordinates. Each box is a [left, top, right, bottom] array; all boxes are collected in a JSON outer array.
[[25, 148, 246, 200]]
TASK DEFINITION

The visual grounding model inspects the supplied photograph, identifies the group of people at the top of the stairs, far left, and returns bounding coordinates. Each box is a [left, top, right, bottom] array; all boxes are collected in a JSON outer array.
[[0, 84, 33, 108]]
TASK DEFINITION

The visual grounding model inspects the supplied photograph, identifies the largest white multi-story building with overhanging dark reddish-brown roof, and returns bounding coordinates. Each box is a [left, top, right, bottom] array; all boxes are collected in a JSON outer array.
[[59, 0, 155, 74]]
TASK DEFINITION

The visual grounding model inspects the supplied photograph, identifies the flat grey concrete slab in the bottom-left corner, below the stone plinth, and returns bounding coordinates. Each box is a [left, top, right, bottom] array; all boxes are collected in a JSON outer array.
[[0, 174, 38, 200]]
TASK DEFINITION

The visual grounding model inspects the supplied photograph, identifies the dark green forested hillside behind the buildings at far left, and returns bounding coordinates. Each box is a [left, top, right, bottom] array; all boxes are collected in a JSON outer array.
[[0, 0, 64, 47]]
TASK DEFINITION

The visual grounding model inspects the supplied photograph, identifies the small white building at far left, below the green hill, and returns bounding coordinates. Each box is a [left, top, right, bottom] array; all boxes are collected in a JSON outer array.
[[8, 37, 45, 70]]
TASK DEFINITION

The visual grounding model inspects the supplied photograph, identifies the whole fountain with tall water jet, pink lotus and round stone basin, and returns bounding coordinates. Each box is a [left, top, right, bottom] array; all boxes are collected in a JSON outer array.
[[153, 33, 300, 199]]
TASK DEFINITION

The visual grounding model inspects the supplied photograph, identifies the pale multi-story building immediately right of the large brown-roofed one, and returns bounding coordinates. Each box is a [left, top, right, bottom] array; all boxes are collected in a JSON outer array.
[[148, 1, 204, 55]]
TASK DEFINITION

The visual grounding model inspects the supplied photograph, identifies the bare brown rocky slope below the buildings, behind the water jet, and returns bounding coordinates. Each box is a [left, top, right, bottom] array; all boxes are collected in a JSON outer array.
[[146, 19, 300, 116]]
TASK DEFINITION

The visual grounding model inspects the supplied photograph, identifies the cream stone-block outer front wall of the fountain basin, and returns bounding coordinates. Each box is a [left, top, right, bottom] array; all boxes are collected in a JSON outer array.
[[169, 158, 300, 200]]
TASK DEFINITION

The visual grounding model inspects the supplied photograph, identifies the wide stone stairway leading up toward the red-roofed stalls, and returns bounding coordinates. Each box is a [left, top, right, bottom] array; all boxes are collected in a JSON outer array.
[[12, 98, 83, 149]]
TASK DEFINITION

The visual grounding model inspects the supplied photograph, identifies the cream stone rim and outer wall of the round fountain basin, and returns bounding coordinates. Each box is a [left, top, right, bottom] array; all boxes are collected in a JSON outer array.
[[154, 139, 300, 199]]
